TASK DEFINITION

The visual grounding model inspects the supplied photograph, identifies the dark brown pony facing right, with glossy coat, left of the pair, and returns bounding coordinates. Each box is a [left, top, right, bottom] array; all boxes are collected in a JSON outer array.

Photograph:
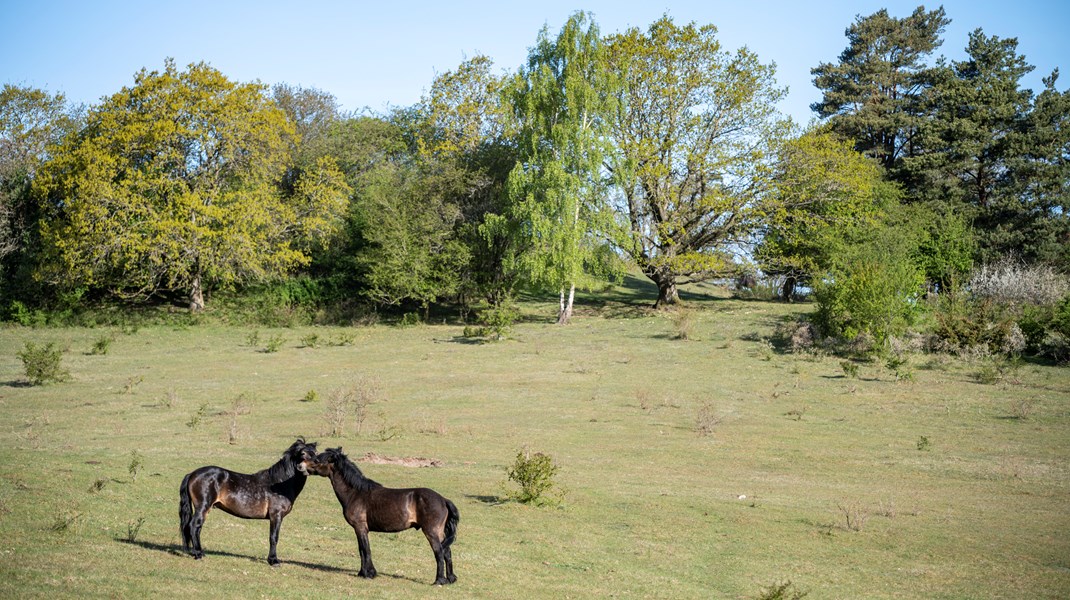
[[179, 437, 316, 567]]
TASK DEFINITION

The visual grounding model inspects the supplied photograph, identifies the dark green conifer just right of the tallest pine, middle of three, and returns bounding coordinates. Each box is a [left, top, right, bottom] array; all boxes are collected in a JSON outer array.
[[902, 29, 1048, 260]]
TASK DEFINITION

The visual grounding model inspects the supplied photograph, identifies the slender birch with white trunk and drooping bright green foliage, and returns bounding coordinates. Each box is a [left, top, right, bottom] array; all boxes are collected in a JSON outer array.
[[506, 13, 618, 324]]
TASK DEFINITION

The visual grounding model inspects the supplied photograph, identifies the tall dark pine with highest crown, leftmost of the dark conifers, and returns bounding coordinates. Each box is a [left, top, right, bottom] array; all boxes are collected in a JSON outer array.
[[811, 6, 950, 169]]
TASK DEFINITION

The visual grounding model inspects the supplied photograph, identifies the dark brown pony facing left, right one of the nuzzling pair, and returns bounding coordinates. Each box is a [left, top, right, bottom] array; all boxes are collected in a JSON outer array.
[[297, 448, 460, 585]]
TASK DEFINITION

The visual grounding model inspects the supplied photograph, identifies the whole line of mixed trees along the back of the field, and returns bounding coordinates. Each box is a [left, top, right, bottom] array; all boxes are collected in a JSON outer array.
[[0, 6, 1070, 344]]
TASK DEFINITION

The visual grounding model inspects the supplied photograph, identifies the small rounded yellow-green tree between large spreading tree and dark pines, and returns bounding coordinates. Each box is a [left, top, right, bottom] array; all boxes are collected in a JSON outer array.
[[754, 126, 892, 299]]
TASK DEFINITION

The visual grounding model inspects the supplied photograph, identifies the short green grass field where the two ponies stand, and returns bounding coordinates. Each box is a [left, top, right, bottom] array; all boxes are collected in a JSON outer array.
[[0, 282, 1070, 599]]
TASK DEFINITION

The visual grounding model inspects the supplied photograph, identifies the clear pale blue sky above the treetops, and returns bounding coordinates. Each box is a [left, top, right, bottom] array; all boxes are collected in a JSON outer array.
[[0, 0, 1070, 123]]
